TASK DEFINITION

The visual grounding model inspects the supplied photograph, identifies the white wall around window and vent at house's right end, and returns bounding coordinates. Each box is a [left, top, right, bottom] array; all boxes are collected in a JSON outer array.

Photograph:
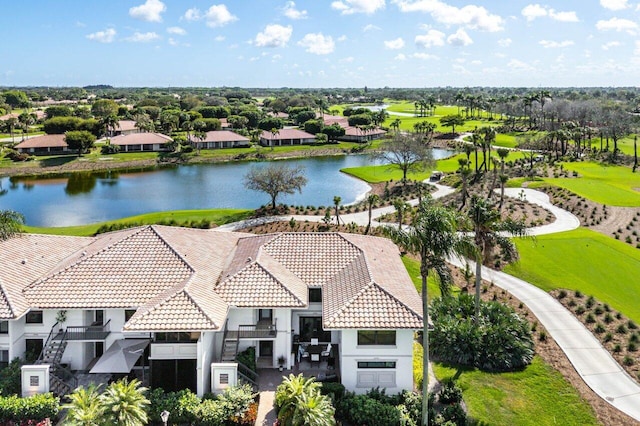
[[340, 330, 413, 394]]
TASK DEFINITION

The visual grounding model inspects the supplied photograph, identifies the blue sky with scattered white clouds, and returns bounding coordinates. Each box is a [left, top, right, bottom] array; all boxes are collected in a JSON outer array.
[[0, 0, 640, 88]]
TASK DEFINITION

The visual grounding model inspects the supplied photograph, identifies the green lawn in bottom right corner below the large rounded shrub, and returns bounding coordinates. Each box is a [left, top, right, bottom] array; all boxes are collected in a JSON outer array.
[[433, 356, 599, 426]]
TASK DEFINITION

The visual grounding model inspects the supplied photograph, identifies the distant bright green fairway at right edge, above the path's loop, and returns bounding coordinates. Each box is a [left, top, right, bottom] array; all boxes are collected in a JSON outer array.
[[545, 162, 640, 207]]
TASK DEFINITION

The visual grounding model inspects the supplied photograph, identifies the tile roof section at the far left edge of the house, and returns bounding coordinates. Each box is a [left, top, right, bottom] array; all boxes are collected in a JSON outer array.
[[0, 234, 94, 319]]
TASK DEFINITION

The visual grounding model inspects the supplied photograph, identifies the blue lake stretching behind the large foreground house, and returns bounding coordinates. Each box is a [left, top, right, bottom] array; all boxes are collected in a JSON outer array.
[[0, 149, 451, 227]]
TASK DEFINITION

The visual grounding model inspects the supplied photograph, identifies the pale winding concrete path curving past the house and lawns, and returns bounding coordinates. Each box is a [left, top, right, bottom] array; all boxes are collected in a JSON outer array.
[[241, 185, 640, 424]]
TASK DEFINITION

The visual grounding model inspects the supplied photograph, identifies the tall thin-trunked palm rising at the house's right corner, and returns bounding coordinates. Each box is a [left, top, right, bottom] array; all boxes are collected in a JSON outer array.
[[384, 197, 471, 426]]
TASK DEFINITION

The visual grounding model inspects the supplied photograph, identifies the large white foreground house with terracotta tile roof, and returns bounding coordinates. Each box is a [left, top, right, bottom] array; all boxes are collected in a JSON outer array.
[[0, 225, 422, 395]]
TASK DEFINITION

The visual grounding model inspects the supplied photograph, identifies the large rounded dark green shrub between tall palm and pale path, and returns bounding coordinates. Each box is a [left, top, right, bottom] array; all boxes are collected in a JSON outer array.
[[430, 293, 534, 371]]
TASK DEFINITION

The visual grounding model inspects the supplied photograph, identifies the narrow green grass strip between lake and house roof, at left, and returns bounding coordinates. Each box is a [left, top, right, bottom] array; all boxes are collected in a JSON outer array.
[[24, 209, 253, 237]]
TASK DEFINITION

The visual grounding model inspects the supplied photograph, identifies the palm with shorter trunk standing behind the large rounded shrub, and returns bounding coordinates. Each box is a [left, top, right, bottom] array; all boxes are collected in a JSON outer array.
[[468, 196, 527, 320]]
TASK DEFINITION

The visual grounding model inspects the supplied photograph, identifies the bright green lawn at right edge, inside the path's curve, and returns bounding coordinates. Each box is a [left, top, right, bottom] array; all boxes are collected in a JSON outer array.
[[505, 228, 640, 322]]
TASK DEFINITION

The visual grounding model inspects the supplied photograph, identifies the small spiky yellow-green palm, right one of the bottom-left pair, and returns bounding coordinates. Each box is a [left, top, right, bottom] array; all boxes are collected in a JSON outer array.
[[100, 379, 150, 426]]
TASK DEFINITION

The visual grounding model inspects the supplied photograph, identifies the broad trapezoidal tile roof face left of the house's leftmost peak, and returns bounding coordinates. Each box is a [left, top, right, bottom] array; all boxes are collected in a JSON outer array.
[[24, 227, 193, 309]]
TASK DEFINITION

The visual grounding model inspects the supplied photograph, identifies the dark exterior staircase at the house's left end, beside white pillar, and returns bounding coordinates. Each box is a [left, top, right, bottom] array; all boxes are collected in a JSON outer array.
[[36, 323, 78, 396]]
